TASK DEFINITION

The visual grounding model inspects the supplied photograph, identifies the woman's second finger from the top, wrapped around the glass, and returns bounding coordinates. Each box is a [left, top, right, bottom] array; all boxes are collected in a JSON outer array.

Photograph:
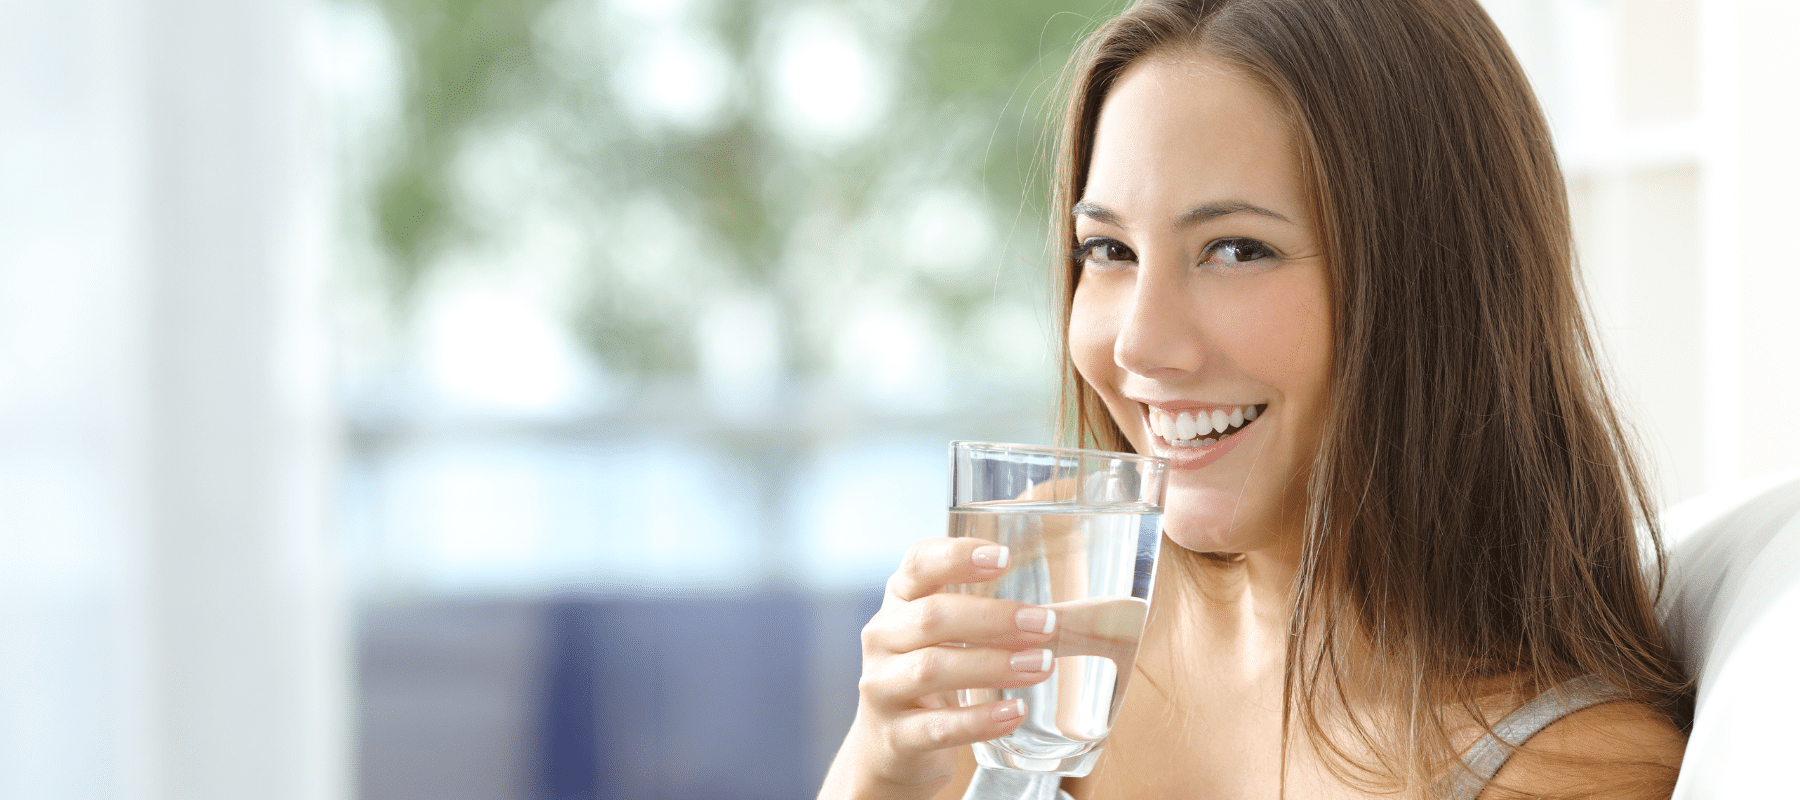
[[862, 595, 1058, 656]]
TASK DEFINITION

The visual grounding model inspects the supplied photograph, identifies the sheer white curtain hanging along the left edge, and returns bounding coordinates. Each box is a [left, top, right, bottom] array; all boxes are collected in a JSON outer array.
[[0, 0, 349, 800]]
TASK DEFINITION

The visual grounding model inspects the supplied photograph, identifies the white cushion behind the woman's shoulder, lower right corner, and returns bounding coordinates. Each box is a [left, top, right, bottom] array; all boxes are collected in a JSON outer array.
[[1661, 472, 1800, 800]]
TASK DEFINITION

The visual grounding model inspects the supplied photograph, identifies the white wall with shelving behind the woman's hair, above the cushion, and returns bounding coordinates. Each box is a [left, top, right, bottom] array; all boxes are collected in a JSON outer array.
[[1485, 0, 1800, 503]]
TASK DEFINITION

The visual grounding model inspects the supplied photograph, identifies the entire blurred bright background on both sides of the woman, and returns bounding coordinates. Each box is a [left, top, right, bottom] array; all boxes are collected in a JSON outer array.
[[0, 0, 1800, 800]]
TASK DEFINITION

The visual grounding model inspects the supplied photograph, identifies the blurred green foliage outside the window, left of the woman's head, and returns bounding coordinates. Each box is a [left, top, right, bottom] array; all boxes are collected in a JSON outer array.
[[351, 0, 1118, 383]]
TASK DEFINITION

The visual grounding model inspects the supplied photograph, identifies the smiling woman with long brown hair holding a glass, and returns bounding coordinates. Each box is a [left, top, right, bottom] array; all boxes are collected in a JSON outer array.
[[823, 0, 1690, 798]]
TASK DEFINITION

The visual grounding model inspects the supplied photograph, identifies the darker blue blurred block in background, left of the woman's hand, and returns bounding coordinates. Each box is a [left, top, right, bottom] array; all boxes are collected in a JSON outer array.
[[540, 593, 855, 800]]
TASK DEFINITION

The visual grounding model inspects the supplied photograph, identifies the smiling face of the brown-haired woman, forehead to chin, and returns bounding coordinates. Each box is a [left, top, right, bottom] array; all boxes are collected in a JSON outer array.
[[1069, 56, 1339, 551]]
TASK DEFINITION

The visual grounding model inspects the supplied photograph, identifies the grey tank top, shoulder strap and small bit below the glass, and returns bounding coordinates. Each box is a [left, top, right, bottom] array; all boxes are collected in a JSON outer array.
[[963, 676, 1625, 800]]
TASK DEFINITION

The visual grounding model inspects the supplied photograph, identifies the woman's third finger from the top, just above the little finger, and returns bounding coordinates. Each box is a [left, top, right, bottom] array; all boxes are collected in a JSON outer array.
[[859, 647, 1055, 712]]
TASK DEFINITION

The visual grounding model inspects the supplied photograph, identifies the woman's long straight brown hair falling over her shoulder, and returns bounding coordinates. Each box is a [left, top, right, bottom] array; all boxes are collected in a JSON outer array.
[[1053, 0, 1692, 795]]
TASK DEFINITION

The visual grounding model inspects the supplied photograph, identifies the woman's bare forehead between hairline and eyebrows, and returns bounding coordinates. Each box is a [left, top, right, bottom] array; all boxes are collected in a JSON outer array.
[[1084, 56, 1305, 218]]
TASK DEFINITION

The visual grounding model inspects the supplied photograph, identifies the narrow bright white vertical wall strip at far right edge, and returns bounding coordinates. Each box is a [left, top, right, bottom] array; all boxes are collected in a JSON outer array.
[[1699, 0, 1800, 479]]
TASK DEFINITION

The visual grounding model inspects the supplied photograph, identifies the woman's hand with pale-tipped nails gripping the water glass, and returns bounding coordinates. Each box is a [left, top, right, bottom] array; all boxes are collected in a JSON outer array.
[[819, 539, 1057, 800]]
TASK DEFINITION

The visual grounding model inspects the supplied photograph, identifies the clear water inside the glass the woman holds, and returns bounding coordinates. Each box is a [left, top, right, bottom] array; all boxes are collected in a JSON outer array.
[[950, 505, 1163, 762]]
